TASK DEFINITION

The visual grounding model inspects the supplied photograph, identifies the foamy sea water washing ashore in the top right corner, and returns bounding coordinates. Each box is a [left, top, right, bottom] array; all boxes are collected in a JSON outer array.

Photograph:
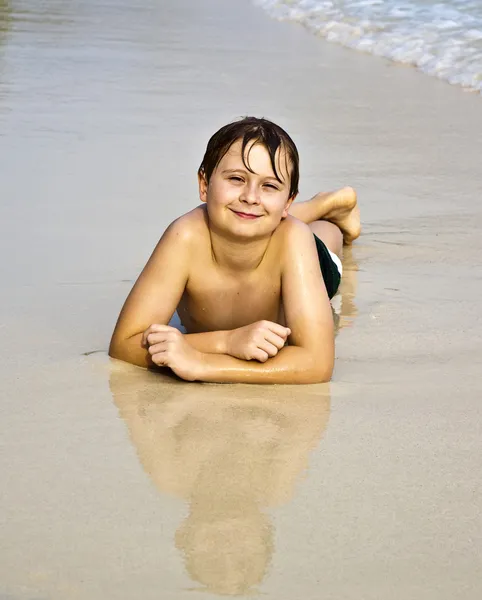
[[254, 0, 482, 93]]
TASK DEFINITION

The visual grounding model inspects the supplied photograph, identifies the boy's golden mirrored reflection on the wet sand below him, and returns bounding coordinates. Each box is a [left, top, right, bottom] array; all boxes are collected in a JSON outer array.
[[110, 370, 330, 595]]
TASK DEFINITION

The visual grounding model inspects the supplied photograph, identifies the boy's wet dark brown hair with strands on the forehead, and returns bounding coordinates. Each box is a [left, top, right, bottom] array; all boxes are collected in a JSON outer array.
[[198, 117, 300, 198]]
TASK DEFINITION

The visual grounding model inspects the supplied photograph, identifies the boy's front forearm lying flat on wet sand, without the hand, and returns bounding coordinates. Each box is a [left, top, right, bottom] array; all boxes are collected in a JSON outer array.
[[197, 346, 333, 383]]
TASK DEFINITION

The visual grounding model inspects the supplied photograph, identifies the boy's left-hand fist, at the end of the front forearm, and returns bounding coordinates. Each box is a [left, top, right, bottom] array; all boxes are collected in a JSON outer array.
[[141, 324, 202, 381]]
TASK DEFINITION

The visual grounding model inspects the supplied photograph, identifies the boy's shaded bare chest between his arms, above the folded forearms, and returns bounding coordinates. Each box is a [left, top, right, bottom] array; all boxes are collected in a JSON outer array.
[[178, 267, 281, 333]]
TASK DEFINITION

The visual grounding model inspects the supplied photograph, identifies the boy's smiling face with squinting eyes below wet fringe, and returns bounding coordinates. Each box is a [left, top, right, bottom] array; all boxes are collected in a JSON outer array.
[[199, 140, 294, 238]]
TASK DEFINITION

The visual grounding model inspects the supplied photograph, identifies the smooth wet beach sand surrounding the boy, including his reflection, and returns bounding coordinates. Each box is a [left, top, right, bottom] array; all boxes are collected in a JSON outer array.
[[0, 0, 482, 600]]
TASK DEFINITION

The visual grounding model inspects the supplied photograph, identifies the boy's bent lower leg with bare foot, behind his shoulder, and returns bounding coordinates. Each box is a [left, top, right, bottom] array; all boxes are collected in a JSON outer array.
[[290, 187, 361, 245]]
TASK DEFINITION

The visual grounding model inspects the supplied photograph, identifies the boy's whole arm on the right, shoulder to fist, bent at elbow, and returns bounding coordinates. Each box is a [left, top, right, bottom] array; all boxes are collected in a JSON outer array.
[[151, 222, 334, 383]]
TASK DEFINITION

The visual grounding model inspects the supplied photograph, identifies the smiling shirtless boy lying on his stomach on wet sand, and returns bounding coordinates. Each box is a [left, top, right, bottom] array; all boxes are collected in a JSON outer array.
[[109, 117, 360, 383]]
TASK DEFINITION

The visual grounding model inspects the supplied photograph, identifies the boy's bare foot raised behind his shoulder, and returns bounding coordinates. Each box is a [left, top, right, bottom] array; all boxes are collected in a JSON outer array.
[[316, 187, 361, 244]]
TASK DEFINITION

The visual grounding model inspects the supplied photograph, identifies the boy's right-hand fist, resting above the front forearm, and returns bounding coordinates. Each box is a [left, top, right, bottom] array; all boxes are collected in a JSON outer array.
[[226, 321, 291, 362]]
